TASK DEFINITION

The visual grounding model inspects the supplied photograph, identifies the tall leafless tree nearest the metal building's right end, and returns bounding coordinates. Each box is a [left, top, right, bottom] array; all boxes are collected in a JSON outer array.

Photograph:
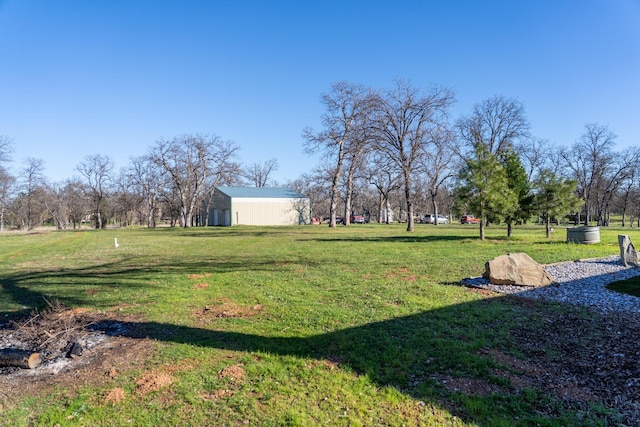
[[302, 81, 373, 227]]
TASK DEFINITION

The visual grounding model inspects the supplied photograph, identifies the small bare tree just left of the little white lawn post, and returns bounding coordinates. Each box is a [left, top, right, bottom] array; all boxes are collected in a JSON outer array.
[[77, 154, 113, 229]]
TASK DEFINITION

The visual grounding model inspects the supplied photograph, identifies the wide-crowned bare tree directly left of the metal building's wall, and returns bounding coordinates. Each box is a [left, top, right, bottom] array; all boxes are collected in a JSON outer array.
[[150, 135, 238, 228]]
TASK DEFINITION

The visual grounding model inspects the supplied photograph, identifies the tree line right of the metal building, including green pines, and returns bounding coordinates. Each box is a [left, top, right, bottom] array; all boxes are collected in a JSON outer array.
[[297, 80, 640, 239]]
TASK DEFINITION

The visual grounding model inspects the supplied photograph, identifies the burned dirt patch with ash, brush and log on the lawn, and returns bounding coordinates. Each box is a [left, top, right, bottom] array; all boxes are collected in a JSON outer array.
[[0, 305, 156, 409]]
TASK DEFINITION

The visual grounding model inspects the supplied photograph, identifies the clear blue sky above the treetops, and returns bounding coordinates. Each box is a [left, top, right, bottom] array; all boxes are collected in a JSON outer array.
[[0, 0, 640, 181]]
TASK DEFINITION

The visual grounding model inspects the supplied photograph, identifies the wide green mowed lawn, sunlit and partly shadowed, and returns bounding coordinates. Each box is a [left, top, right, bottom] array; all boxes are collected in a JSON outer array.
[[0, 224, 635, 426]]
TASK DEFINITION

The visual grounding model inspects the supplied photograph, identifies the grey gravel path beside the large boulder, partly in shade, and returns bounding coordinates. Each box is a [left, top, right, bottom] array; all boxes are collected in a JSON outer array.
[[462, 256, 640, 313]]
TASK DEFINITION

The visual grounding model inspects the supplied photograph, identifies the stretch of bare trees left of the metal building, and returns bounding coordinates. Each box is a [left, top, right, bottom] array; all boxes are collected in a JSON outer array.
[[0, 134, 278, 230]]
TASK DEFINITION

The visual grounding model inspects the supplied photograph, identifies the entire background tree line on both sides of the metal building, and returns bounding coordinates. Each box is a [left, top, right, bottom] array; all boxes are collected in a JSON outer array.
[[0, 80, 640, 238]]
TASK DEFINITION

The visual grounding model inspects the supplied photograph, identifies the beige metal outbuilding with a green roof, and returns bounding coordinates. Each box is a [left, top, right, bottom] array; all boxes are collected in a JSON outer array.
[[207, 187, 311, 226]]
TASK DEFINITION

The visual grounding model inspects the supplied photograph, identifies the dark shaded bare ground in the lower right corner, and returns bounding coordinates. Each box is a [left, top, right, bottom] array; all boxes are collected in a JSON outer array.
[[484, 297, 640, 425]]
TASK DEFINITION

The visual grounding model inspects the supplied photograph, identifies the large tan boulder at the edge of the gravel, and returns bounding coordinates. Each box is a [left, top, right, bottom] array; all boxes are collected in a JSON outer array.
[[483, 253, 554, 287]]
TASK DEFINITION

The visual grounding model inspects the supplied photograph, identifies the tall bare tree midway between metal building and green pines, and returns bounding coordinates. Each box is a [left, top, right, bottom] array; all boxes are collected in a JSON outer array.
[[375, 80, 454, 231]]
